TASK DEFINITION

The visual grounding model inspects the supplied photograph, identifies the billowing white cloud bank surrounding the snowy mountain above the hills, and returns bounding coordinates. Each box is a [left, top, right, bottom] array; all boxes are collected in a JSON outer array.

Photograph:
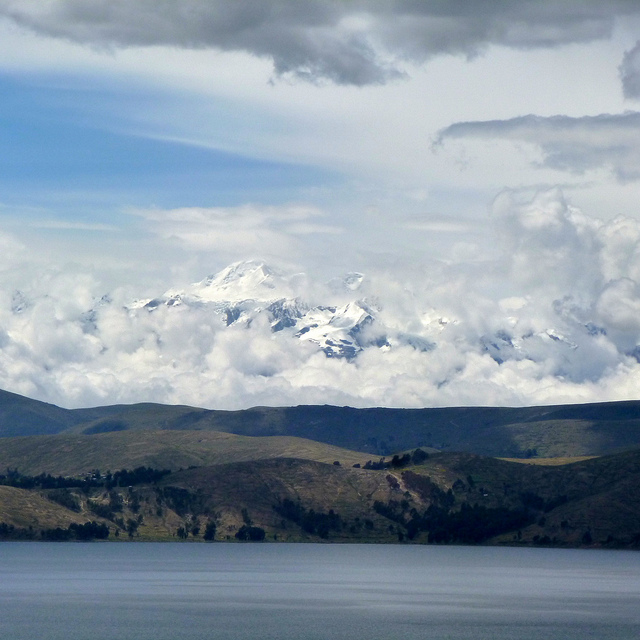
[[0, 190, 640, 408]]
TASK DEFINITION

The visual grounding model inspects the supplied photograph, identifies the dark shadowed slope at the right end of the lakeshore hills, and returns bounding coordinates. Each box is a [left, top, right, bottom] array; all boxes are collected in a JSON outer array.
[[410, 451, 640, 546]]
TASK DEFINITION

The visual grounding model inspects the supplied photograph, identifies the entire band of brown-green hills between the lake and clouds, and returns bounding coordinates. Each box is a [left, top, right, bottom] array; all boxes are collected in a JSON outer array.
[[0, 392, 640, 548]]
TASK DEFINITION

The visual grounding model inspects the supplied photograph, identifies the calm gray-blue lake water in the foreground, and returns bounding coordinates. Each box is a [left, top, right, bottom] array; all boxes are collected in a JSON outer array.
[[0, 542, 640, 640]]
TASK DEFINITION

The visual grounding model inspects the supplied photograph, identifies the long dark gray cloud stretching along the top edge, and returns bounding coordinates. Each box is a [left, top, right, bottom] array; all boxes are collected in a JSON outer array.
[[0, 0, 640, 85]]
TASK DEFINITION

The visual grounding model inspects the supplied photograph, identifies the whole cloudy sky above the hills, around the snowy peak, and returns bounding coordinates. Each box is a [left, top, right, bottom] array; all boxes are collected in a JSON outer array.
[[0, 0, 640, 408]]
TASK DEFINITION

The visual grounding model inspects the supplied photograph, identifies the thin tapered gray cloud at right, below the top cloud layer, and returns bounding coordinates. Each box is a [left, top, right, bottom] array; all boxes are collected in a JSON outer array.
[[436, 111, 640, 182]]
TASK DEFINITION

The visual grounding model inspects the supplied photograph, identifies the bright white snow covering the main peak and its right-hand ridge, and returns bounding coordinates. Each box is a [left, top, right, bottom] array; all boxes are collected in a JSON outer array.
[[102, 261, 624, 364]]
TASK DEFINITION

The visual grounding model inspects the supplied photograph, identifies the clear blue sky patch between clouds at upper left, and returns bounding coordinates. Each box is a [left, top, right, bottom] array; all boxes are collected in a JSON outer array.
[[0, 74, 336, 216]]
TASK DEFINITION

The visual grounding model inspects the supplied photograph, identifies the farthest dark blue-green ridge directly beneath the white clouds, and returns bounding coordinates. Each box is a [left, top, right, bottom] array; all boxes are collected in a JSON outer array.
[[0, 392, 640, 458]]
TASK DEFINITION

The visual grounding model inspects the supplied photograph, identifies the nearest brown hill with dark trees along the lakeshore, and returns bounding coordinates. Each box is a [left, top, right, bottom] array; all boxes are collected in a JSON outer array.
[[0, 451, 640, 548]]
